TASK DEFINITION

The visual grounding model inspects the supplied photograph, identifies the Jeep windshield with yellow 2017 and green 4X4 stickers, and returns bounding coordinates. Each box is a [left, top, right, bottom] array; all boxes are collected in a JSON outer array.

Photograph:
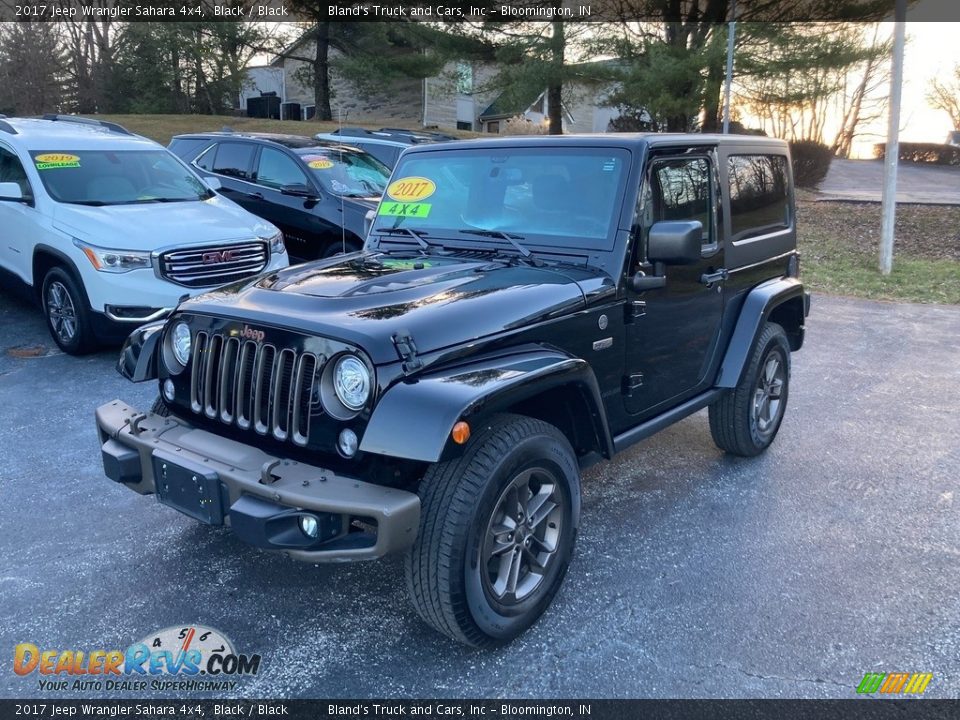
[[374, 147, 630, 248]]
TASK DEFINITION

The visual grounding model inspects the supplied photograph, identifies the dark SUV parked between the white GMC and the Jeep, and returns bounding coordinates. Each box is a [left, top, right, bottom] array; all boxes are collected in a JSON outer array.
[[170, 132, 390, 260]]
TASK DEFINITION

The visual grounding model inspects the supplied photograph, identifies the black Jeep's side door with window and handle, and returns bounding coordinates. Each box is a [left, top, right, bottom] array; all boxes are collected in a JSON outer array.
[[623, 148, 723, 420]]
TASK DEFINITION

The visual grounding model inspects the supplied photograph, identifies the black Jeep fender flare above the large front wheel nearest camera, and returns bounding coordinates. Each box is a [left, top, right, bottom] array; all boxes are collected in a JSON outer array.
[[360, 348, 613, 463]]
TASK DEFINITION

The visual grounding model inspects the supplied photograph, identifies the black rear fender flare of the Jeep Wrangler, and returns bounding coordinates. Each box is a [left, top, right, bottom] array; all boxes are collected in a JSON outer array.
[[715, 278, 810, 388]]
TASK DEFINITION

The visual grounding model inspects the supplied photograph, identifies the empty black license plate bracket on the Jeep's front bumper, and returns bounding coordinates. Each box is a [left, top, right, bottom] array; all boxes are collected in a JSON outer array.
[[153, 450, 223, 525]]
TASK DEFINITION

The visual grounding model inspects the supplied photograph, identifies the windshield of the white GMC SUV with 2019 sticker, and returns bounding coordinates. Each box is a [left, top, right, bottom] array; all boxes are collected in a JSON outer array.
[[31, 150, 213, 205]]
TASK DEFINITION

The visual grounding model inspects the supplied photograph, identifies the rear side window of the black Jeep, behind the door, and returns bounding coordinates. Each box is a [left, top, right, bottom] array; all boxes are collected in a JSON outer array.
[[727, 155, 790, 240]]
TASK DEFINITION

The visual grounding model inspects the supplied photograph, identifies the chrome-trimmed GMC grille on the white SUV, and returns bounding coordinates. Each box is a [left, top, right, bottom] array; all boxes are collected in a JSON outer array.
[[160, 242, 269, 287]]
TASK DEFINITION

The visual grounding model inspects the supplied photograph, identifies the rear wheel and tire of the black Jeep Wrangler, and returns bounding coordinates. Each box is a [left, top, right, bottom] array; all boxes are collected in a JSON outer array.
[[710, 323, 790, 457]]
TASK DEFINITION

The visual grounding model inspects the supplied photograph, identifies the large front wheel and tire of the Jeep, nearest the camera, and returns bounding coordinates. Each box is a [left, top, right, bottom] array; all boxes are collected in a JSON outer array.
[[406, 415, 580, 647]]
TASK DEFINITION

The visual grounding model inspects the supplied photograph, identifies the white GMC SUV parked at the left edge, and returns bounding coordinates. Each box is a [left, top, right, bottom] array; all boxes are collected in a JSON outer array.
[[0, 115, 289, 354]]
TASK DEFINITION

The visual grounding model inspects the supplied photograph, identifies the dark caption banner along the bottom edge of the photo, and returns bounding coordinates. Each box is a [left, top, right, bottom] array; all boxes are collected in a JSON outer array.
[[0, 699, 960, 720]]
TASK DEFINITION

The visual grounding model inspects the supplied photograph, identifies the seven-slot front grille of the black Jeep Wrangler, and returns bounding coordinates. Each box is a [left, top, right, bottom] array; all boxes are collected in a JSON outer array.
[[190, 332, 320, 445]]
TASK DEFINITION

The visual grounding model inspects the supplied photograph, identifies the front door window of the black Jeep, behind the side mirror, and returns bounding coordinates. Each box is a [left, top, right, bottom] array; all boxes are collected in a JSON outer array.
[[641, 157, 716, 246]]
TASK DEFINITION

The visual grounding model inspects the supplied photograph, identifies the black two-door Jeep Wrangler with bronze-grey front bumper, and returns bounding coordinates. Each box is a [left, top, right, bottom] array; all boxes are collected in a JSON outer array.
[[96, 135, 809, 645]]
